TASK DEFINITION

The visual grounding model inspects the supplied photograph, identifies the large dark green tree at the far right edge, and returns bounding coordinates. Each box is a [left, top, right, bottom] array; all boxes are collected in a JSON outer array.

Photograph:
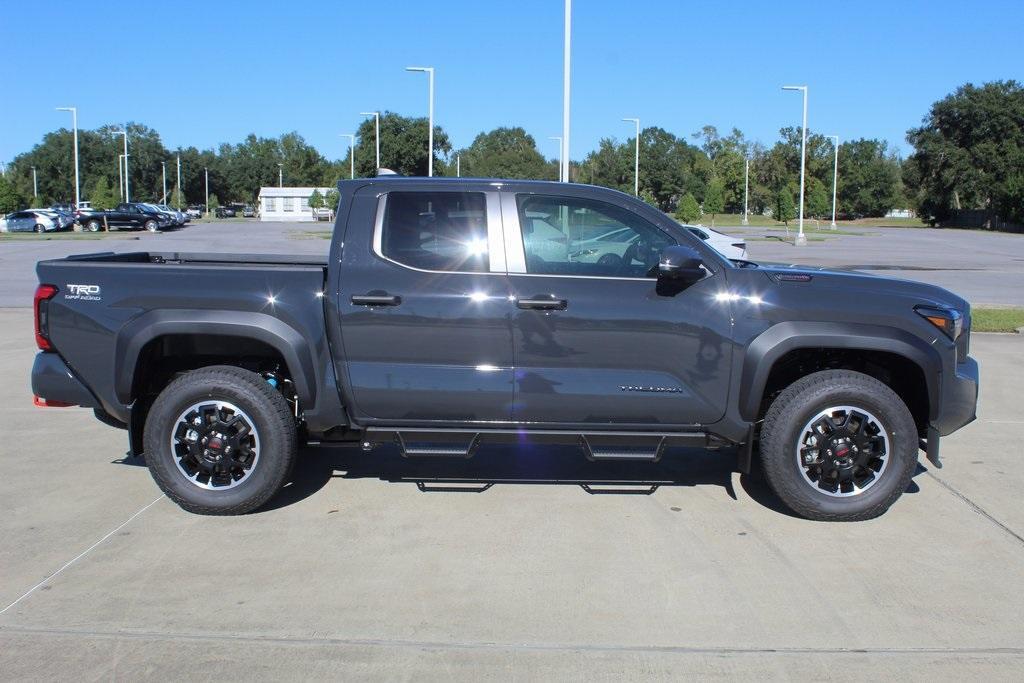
[[903, 81, 1024, 225]]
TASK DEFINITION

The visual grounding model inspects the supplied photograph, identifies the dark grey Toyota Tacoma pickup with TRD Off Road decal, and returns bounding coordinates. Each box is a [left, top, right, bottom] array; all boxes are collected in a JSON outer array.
[[32, 176, 978, 520]]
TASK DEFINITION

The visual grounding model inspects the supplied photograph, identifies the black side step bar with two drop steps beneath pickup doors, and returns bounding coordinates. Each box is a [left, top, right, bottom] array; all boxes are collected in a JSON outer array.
[[364, 427, 720, 462]]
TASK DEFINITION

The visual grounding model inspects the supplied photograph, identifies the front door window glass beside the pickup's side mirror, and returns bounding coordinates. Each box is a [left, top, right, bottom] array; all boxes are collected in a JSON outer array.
[[518, 195, 674, 278]]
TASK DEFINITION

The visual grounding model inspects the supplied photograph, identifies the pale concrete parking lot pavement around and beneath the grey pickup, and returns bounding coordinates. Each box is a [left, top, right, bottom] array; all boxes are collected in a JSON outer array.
[[0, 222, 1024, 680]]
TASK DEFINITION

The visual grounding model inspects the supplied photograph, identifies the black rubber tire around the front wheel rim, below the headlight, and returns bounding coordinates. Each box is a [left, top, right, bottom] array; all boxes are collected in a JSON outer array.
[[760, 370, 919, 521]]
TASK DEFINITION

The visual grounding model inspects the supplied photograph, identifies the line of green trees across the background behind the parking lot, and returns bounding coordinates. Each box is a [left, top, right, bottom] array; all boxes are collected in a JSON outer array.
[[0, 81, 1024, 229]]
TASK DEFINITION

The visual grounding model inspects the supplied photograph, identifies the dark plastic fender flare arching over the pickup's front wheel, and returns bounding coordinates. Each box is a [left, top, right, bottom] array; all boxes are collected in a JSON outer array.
[[739, 321, 942, 422]]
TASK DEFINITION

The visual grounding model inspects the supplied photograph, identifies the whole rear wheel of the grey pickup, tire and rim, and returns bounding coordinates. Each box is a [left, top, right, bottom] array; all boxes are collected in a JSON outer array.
[[144, 366, 298, 515]]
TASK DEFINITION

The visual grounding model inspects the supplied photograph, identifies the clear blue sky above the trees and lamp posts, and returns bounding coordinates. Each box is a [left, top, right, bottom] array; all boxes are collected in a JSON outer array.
[[0, 0, 1024, 161]]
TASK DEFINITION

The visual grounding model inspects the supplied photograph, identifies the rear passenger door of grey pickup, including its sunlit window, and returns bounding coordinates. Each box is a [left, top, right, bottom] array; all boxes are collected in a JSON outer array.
[[335, 185, 512, 425]]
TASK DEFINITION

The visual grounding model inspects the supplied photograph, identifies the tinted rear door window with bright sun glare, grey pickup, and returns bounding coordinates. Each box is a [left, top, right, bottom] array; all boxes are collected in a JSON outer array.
[[381, 193, 489, 272]]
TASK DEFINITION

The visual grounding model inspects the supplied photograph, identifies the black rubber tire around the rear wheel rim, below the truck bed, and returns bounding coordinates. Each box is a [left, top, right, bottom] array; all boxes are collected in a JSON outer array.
[[143, 366, 298, 515]]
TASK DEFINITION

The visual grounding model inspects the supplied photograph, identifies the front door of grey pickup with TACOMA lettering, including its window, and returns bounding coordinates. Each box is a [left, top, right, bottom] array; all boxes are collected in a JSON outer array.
[[502, 194, 731, 428]]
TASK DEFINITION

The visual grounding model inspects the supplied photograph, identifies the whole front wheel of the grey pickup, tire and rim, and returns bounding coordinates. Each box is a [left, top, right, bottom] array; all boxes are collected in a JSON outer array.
[[761, 370, 918, 521]]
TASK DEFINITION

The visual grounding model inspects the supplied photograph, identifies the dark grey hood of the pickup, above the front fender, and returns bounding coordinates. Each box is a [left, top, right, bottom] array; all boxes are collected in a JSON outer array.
[[757, 263, 970, 311]]
